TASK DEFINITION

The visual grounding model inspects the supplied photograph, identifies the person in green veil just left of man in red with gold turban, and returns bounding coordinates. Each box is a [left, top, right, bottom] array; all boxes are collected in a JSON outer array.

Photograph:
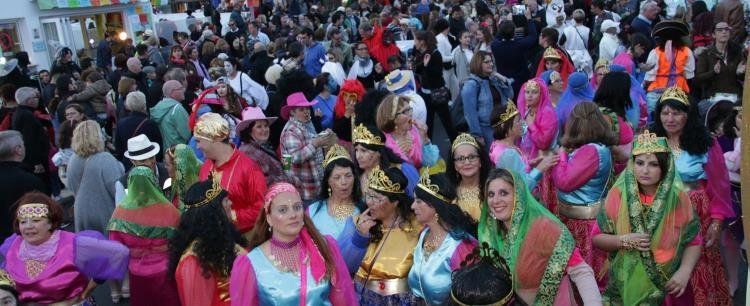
[[164, 144, 202, 211]]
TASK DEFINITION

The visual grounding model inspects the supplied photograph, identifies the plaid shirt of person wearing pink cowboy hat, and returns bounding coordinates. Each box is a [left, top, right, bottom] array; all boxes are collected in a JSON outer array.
[[281, 118, 324, 200]]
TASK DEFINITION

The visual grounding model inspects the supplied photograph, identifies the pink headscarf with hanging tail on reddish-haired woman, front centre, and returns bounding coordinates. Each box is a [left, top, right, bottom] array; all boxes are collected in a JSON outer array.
[[263, 182, 326, 306]]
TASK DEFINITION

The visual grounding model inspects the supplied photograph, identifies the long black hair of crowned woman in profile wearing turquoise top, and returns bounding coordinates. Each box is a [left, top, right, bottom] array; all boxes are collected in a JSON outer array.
[[414, 174, 477, 239]]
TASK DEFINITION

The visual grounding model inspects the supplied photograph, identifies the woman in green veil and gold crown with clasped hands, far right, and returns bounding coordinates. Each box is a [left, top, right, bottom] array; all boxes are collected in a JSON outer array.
[[593, 130, 702, 305]]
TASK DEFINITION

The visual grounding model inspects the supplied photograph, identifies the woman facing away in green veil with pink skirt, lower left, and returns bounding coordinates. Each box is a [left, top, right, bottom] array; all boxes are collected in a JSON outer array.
[[107, 166, 180, 306]]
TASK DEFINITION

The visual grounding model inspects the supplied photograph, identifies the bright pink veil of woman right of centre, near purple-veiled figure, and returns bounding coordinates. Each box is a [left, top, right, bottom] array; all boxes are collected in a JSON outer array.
[[517, 78, 558, 159]]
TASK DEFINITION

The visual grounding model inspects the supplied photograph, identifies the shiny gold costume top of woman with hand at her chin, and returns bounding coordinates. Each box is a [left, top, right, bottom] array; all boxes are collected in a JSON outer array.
[[355, 220, 421, 280]]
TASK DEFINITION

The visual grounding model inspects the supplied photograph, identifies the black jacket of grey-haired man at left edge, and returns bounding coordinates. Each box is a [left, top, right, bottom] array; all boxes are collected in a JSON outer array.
[[0, 160, 49, 240]]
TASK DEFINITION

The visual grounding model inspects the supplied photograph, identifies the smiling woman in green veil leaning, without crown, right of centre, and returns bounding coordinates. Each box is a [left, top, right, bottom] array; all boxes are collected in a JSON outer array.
[[479, 169, 601, 305]]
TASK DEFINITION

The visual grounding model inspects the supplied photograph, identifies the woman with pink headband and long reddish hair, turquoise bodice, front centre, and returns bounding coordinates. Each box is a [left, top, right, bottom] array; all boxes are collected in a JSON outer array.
[[229, 182, 356, 306]]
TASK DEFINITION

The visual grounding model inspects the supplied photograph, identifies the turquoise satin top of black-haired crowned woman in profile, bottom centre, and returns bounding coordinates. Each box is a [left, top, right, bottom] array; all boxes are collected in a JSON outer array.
[[409, 229, 461, 305]]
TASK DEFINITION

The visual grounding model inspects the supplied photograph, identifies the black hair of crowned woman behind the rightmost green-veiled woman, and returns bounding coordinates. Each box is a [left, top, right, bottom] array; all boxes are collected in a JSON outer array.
[[651, 99, 713, 155]]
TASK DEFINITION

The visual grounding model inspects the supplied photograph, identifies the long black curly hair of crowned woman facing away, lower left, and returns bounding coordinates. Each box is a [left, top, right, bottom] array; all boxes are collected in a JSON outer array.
[[169, 180, 248, 277]]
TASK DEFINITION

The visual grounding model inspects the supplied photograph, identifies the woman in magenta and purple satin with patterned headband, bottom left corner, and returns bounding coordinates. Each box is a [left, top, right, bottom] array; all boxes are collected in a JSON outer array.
[[0, 192, 128, 305]]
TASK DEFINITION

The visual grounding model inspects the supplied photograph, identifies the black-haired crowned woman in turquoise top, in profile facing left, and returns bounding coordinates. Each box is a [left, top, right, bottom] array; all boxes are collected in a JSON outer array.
[[409, 173, 477, 305]]
